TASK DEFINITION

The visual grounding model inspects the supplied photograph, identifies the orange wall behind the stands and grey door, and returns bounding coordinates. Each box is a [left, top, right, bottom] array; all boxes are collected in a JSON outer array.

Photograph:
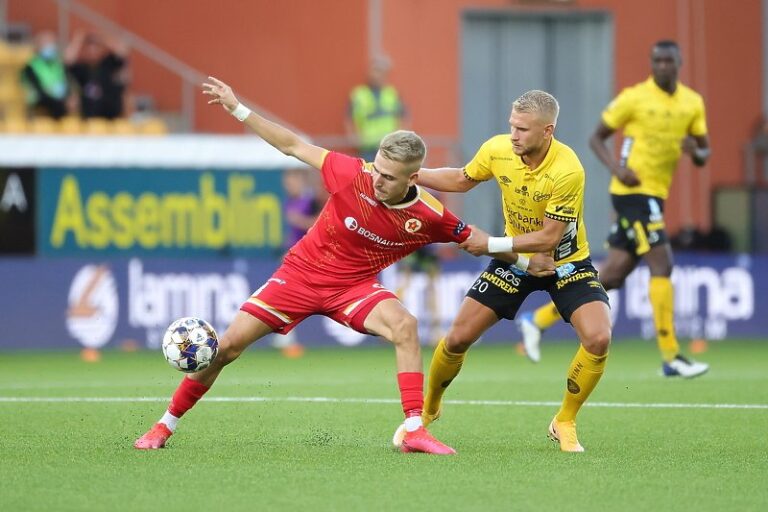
[[9, 0, 763, 230]]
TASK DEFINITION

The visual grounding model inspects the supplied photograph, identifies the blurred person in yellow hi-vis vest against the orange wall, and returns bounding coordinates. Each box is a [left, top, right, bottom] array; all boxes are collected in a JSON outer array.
[[344, 57, 407, 162]]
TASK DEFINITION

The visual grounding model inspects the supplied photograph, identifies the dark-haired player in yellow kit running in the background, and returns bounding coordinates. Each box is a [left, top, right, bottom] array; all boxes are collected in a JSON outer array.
[[518, 41, 709, 378]]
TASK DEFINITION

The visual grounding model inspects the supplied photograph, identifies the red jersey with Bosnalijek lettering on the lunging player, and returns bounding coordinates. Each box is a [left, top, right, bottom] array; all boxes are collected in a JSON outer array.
[[284, 152, 470, 282]]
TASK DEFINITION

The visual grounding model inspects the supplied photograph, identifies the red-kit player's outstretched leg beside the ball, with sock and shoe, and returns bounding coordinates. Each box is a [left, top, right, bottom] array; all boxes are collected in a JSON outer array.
[[133, 311, 272, 450]]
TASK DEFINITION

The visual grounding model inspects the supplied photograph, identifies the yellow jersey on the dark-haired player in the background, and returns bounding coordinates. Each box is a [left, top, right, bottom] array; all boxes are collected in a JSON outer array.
[[603, 77, 707, 199]]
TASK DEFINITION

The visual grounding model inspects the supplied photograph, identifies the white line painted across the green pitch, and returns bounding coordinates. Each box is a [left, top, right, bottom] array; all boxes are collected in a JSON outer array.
[[0, 396, 768, 410]]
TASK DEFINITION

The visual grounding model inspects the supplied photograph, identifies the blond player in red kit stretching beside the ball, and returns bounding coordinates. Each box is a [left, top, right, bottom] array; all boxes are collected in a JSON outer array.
[[134, 77, 554, 455]]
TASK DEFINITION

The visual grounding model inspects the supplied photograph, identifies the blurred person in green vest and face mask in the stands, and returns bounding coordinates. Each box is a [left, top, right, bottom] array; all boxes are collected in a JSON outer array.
[[21, 31, 70, 119]]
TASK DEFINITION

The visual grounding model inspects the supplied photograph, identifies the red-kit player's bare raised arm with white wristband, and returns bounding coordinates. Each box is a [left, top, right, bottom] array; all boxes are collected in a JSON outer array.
[[203, 76, 326, 169]]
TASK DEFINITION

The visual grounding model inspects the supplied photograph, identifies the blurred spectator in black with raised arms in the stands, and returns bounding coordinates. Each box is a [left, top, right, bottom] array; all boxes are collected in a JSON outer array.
[[64, 32, 128, 119]]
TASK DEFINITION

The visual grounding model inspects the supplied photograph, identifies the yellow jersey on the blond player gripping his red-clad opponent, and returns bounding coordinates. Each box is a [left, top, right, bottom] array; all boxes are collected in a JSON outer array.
[[464, 134, 589, 264]]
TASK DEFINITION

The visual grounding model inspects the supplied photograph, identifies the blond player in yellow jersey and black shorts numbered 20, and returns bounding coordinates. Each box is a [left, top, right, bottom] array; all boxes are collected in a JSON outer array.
[[393, 90, 611, 452]]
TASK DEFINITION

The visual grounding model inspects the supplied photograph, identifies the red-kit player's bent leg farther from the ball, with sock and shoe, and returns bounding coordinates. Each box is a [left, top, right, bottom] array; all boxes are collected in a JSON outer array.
[[364, 299, 456, 455]]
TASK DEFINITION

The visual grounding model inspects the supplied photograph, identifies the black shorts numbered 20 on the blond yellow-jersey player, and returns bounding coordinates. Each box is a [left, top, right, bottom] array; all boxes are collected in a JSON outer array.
[[467, 258, 610, 323]]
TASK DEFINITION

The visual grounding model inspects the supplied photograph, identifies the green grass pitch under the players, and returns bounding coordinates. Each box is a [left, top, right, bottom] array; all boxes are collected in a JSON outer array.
[[0, 340, 768, 512]]
